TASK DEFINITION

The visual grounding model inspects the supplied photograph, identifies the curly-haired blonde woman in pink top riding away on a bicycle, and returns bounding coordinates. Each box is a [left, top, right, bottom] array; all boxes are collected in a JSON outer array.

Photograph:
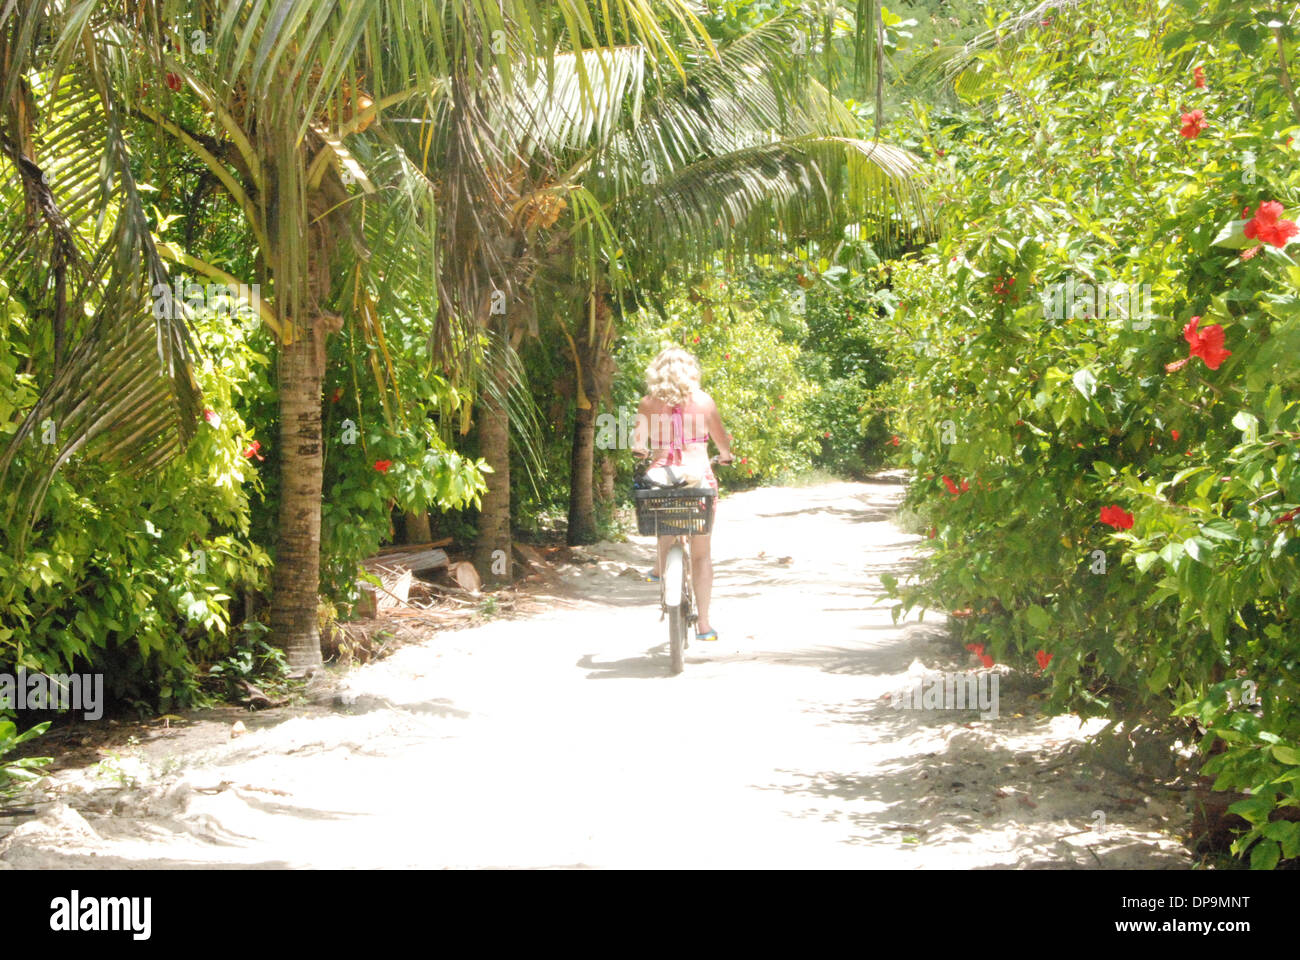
[[632, 347, 732, 640]]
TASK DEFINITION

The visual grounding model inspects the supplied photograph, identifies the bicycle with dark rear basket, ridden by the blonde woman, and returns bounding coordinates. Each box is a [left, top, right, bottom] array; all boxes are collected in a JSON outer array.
[[632, 457, 719, 675]]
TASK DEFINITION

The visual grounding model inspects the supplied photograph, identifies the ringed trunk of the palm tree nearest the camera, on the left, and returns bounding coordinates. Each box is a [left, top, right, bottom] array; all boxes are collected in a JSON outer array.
[[270, 328, 325, 674]]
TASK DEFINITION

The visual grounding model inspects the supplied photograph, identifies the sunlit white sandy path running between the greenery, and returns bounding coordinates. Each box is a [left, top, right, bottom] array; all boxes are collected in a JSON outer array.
[[0, 479, 1190, 869]]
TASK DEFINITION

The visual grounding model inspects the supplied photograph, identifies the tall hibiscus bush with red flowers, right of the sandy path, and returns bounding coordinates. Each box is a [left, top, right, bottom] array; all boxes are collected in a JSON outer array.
[[884, 0, 1300, 869]]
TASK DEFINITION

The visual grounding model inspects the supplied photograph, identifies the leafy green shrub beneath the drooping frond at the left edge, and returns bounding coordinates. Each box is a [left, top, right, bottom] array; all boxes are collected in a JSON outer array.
[[0, 287, 268, 708]]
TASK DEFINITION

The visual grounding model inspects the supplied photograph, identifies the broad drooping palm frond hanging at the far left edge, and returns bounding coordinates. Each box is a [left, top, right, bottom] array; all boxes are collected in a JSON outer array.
[[0, 42, 200, 541]]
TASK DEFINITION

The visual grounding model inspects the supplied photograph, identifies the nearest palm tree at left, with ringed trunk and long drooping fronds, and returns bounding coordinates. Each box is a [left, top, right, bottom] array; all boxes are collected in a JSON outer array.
[[0, 0, 703, 673]]
